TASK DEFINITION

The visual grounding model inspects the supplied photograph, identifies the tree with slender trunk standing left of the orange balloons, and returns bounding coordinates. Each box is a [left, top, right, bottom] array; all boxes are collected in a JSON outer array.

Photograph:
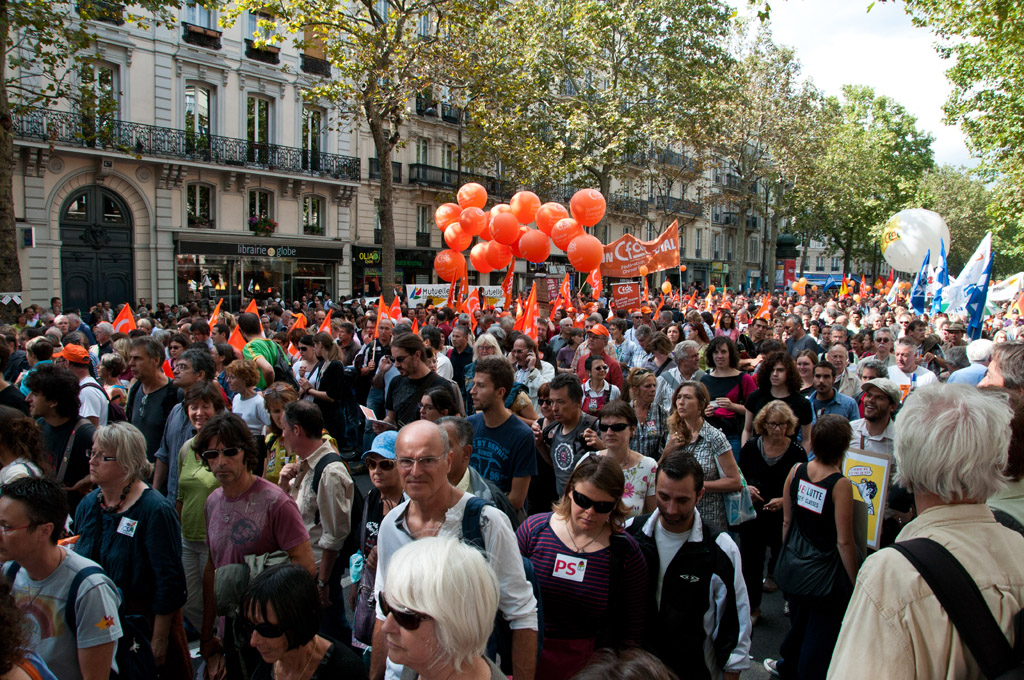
[[222, 0, 496, 303]]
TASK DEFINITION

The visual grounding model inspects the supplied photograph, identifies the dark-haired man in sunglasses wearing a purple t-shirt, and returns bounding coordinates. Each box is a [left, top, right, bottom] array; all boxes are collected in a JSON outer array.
[[193, 412, 315, 678]]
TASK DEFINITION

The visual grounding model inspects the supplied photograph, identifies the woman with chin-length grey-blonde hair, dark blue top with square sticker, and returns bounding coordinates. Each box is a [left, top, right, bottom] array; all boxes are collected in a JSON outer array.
[[75, 422, 191, 678]]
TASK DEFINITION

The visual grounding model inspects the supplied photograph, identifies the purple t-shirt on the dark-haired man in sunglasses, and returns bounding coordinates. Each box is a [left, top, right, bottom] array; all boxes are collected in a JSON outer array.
[[206, 477, 309, 568]]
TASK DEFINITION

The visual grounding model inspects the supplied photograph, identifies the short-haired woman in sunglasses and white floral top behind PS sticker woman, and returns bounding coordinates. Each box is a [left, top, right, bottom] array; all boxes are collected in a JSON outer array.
[[587, 399, 657, 517]]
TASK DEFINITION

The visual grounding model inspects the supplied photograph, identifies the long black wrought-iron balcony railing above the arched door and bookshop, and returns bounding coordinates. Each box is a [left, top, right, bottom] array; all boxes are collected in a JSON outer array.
[[13, 109, 361, 181]]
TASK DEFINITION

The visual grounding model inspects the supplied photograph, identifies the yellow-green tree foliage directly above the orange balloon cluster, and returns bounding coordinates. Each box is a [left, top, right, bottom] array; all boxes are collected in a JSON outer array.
[[470, 0, 732, 209]]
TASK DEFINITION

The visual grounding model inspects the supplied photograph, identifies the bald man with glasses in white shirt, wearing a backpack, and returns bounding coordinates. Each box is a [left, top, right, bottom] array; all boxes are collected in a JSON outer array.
[[370, 421, 538, 680]]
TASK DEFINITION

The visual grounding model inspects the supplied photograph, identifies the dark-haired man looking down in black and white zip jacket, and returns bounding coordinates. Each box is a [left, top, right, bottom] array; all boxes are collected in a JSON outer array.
[[627, 451, 751, 680]]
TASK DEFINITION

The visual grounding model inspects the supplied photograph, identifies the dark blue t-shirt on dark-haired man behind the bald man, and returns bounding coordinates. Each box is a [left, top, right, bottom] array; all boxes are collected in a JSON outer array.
[[468, 413, 537, 494]]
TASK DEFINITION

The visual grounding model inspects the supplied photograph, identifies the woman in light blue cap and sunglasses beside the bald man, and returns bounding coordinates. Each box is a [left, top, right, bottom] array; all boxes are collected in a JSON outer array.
[[348, 430, 402, 644]]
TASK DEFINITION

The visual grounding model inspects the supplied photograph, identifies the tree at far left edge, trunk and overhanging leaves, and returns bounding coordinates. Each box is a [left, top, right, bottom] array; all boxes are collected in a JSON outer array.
[[0, 0, 180, 321]]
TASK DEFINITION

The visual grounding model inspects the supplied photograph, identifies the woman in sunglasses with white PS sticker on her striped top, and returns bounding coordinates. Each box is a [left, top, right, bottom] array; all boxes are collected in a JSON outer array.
[[512, 456, 647, 680]]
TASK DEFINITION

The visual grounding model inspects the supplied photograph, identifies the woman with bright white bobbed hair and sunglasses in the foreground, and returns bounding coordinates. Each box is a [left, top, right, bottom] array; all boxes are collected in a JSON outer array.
[[378, 537, 506, 680]]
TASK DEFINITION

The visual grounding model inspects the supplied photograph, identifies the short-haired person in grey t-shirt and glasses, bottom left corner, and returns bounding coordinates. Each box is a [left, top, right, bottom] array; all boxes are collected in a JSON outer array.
[[0, 477, 122, 680]]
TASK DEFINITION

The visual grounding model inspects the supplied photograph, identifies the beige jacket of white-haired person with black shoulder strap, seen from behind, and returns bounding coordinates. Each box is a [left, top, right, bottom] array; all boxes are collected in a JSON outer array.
[[828, 504, 1024, 680]]
